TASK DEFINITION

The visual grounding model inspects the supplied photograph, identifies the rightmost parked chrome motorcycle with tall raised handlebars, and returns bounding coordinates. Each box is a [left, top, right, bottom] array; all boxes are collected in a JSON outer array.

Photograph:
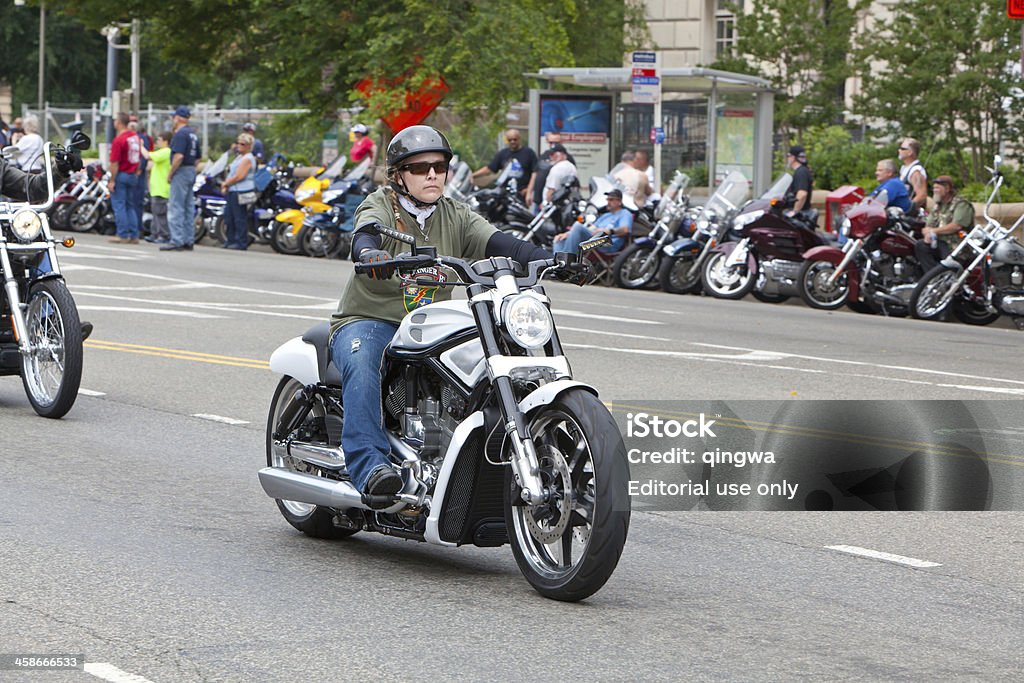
[[910, 156, 1024, 330]]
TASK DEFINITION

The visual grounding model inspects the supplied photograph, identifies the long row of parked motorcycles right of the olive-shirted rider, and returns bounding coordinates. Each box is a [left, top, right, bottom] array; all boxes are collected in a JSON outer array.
[[462, 152, 1024, 329]]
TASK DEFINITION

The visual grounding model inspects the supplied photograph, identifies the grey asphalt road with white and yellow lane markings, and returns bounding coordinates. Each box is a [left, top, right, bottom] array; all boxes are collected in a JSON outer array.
[[0, 234, 1024, 682]]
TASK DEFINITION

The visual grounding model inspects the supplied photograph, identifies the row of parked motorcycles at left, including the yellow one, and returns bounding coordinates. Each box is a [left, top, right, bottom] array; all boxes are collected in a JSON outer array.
[[49, 152, 373, 258]]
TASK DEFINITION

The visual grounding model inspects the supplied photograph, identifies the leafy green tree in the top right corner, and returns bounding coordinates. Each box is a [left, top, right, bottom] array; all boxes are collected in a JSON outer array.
[[857, 0, 1024, 181]]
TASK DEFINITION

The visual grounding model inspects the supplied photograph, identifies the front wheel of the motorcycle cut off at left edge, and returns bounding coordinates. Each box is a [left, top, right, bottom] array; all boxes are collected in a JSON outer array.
[[22, 280, 82, 419]]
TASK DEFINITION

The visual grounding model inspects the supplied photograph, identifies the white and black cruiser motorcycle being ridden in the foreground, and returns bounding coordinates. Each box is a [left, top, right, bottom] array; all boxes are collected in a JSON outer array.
[[259, 228, 630, 601]]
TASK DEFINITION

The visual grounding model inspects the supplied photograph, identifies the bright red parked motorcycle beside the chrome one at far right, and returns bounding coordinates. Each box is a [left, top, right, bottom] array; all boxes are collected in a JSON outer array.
[[797, 191, 925, 316]]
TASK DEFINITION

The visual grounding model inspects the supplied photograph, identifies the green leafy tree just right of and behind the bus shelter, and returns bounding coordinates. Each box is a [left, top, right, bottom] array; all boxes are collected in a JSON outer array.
[[713, 0, 870, 138]]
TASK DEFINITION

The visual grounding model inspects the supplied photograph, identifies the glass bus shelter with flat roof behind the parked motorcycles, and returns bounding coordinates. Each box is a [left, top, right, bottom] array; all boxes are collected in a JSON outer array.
[[527, 68, 775, 194]]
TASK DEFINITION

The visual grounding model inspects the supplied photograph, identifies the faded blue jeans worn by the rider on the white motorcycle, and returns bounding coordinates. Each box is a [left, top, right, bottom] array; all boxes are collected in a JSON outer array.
[[331, 321, 398, 492]]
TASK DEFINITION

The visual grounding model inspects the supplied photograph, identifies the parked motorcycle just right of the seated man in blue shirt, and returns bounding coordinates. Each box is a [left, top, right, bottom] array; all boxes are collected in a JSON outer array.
[[611, 171, 693, 290]]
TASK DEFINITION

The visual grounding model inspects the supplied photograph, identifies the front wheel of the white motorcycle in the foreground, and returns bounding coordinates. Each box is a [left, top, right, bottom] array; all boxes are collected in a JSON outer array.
[[505, 388, 630, 602]]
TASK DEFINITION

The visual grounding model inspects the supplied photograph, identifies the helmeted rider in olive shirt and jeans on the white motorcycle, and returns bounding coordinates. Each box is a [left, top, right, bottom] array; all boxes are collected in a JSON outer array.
[[331, 126, 551, 506]]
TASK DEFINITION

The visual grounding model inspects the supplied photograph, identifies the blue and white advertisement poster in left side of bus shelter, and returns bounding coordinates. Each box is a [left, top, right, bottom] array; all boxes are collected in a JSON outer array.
[[537, 95, 611, 186]]
